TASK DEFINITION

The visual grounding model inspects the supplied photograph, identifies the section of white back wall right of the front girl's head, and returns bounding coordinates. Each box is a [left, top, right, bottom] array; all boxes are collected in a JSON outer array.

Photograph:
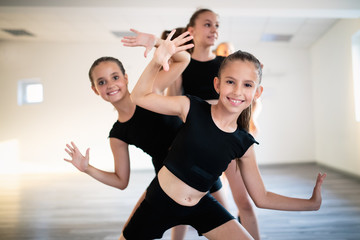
[[251, 46, 315, 164]]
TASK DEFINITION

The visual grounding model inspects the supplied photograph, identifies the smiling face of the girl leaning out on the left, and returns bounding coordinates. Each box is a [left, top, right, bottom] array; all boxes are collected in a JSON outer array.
[[91, 61, 129, 103]]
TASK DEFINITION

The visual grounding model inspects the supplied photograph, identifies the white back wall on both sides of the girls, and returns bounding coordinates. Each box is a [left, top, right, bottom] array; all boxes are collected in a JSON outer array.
[[0, 42, 315, 172]]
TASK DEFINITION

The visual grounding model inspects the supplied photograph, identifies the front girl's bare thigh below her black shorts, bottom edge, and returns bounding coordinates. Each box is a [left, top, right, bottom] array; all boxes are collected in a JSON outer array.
[[203, 219, 253, 240]]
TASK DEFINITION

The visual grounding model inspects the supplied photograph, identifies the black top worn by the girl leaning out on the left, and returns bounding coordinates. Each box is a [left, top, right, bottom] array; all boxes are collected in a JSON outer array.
[[109, 106, 183, 172]]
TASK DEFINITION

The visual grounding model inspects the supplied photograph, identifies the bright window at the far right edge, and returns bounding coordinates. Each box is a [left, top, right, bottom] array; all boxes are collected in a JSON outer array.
[[352, 31, 360, 122]]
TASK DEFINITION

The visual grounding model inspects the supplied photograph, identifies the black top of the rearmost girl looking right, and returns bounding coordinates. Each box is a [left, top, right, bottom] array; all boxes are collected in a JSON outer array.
[[182, 56, 225, 100]]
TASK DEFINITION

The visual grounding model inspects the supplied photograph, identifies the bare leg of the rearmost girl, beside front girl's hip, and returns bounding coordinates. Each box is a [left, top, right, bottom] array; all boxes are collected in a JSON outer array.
[[225, 160, 260, 239]]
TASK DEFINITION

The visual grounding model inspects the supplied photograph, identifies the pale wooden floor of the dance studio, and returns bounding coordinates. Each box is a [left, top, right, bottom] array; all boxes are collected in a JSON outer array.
[[0, 164, 360, 240]]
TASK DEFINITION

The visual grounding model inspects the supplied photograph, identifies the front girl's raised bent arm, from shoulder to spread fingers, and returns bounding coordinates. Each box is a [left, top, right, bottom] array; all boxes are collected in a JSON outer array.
[[131, 30, 193, 121]]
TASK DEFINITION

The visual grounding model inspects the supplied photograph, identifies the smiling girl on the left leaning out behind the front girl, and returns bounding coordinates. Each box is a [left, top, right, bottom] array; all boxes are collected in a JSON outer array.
[[65, 31, 194, 235]]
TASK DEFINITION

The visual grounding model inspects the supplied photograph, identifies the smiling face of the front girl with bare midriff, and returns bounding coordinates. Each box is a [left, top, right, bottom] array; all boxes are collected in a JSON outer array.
[[214, 59, 262, 114]]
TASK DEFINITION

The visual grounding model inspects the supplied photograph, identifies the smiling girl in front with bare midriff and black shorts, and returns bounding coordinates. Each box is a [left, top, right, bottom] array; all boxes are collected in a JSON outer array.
[[120, 32, 326, 239]]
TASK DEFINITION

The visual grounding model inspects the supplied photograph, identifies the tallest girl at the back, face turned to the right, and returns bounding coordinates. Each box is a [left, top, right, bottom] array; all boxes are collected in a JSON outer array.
[[122, 9, 260, 239]]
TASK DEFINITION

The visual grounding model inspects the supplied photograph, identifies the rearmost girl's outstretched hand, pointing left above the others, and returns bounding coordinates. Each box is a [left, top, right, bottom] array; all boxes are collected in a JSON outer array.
[[121, 29, 157, 57]]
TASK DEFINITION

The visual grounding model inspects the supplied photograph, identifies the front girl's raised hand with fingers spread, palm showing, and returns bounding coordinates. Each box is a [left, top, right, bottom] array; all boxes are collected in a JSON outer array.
[[153, 30, 194, 71]]
